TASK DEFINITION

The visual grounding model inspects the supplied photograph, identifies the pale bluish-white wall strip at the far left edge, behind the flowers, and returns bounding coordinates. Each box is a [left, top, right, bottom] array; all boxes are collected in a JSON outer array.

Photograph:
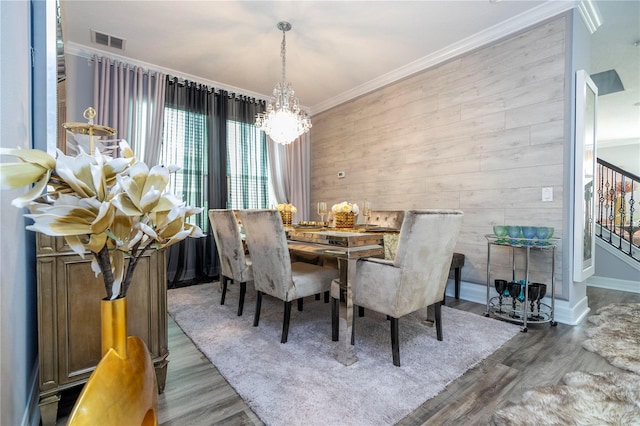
[[0, 1, 36, 425]]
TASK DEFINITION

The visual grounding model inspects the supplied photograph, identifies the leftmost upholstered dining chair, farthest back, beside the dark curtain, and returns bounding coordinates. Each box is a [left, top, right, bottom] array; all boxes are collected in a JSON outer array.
[[209, 209, 253, 316]]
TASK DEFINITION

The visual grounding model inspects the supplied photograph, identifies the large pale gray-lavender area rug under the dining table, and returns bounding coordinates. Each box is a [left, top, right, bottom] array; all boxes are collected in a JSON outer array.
[[168, 283, 520, 426]]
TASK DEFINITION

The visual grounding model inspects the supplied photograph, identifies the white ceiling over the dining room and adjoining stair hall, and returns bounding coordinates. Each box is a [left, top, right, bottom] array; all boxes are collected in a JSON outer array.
[[59, 0, 640, 145]]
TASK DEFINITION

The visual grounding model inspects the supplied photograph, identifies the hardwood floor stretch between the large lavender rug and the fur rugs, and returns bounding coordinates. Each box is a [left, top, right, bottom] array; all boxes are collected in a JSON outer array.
[[398, 287, 640, 425]]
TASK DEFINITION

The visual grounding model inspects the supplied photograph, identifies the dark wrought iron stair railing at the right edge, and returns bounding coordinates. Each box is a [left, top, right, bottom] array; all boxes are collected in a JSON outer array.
[[596, 158, 640, 262]]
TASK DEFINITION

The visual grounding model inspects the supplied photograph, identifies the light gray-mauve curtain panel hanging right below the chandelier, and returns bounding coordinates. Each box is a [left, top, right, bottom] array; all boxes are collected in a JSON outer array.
[[268, 133, 314, 220]]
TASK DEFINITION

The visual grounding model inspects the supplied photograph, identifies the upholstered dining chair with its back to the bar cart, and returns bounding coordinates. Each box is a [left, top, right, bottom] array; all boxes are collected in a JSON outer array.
[[331, 210, 463, 367]]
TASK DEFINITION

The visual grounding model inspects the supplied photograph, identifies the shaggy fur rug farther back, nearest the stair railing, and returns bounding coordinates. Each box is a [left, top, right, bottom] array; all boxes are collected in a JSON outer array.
[[582, 303, 640, 374]]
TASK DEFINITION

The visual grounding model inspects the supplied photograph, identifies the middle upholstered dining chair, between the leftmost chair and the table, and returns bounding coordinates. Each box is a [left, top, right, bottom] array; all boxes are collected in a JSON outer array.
[[240, 210, 338, 343]]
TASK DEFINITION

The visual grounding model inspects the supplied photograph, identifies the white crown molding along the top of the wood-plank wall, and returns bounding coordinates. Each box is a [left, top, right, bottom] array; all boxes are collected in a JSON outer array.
[[309, 0, 576, 116]]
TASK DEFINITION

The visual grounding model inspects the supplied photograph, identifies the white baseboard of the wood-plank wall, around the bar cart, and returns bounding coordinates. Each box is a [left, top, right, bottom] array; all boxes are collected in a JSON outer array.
[[447, 279, 590, 325]]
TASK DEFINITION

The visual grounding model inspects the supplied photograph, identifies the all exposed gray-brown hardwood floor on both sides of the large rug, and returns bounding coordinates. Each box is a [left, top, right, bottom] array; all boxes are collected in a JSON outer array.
[[58, 287, 640, 426]]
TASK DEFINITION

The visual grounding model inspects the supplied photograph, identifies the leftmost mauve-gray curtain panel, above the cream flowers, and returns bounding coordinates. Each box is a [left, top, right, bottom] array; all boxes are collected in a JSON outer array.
[[93, 56, 166, 167]]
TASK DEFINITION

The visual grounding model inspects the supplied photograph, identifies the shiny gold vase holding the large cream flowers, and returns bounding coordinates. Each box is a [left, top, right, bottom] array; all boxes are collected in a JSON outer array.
[[67, 297, 158, 426]]
